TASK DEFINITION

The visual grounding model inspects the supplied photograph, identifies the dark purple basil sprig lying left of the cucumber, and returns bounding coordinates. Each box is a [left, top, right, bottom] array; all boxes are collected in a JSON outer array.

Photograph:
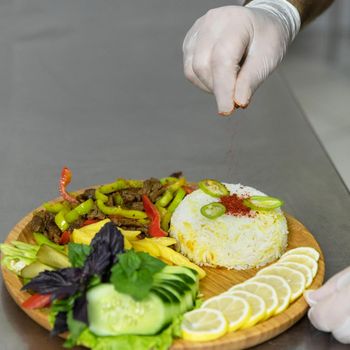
[[22, 222, 124, 338]]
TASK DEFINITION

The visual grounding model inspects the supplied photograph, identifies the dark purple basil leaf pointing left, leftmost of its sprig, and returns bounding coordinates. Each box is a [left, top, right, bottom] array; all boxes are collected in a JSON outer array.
[[22, 267, 83, 299]]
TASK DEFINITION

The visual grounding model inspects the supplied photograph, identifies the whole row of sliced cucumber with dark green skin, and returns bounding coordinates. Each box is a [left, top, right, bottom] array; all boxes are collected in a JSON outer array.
[[87, 266, 198, 336]]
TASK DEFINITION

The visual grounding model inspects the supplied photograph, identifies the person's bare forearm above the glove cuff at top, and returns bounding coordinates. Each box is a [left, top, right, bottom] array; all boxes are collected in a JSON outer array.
[[245, 0, 334, 26]]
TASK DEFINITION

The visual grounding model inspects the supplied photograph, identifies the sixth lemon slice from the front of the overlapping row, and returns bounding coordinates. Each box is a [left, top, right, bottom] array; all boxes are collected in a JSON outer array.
[[257, 264, 306, 302]]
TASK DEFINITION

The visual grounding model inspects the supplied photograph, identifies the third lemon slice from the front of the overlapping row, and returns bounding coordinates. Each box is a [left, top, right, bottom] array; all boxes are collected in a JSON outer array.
[[225, 289, 266, 329]]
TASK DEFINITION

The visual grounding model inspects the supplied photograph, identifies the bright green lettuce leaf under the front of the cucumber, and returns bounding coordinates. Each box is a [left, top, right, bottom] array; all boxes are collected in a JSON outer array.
[[77, 316, 182, 350]]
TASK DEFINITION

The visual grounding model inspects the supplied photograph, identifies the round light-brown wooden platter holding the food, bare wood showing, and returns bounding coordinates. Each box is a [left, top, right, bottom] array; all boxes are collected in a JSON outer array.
[[1, 201, 325, 350]]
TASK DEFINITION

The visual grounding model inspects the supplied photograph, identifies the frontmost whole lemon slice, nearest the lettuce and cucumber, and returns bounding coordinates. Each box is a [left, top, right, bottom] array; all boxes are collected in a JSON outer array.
[[181, 308, 227, 341]]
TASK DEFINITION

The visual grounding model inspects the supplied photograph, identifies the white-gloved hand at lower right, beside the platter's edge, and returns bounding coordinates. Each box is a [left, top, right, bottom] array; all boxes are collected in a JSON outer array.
[[305, 267, 350, 344]]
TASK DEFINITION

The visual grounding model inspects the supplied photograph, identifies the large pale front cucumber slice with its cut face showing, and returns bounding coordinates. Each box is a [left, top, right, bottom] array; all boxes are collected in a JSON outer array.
[[87, 283, 169, 336]]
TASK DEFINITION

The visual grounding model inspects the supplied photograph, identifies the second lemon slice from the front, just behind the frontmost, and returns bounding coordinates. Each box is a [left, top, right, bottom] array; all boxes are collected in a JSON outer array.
[[201, 295, 251, 332]]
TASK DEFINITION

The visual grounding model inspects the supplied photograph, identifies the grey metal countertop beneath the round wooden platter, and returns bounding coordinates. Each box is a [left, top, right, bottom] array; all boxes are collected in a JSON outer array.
[[0, 0, 350, 350]]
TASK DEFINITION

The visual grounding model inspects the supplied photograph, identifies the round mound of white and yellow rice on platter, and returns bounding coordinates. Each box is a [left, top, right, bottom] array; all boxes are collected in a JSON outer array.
[[170, 184, 288, 270]]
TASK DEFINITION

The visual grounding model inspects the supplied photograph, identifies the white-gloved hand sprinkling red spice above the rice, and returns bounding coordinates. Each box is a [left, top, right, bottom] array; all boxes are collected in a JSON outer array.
[[183, 0, 300, 115]]
